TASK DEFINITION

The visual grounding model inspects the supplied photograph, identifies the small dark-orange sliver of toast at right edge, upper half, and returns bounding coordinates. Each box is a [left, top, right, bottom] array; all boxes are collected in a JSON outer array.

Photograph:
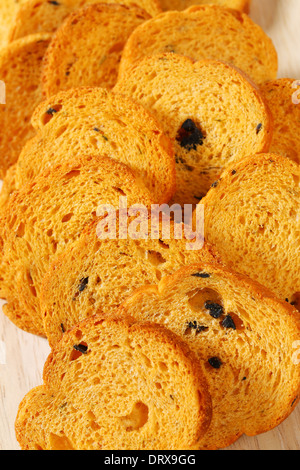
[[261, 78, 300, 164]]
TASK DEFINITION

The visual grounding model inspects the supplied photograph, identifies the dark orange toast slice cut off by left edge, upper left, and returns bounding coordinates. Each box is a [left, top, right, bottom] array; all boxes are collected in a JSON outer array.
[[0, 34, 50, 179]]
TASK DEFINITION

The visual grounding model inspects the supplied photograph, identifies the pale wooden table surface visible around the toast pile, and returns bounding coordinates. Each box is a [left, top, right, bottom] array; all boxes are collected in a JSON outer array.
[[0, 0, 300, 450]]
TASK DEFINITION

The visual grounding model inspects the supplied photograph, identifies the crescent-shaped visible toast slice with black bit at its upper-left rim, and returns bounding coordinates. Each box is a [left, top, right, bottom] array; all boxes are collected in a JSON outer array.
[[15, 88, 176, 203]]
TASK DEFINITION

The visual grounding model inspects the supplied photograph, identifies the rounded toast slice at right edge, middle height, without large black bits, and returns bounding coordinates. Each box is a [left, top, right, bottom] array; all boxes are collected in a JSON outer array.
[[201, 154, 300, 302]]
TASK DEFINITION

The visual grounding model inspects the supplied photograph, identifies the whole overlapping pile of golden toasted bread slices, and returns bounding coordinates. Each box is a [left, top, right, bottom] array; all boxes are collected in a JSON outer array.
[[0, 0, 300, 450]]
